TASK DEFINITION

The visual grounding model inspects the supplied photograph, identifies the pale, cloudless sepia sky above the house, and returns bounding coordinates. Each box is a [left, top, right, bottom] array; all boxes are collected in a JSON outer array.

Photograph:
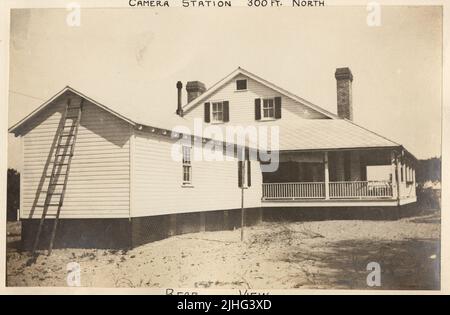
[[8, 6, 442, 170]]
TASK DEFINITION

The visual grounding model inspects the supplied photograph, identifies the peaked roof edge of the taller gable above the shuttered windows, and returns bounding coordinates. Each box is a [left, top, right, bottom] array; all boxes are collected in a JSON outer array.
[[183, 67, 340, 119]]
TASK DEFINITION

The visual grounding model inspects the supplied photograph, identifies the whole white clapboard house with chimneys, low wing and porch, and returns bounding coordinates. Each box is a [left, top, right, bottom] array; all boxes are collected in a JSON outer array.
[[9, 68, 416, 252]]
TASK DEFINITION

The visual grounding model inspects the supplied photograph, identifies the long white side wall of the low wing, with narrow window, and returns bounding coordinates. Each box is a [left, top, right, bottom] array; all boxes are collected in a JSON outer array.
[[131, 131, 262, 217]]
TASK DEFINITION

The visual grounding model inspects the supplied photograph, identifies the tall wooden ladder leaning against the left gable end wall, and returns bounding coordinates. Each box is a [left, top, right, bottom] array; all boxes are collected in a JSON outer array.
[[32, 99, 83, 255]]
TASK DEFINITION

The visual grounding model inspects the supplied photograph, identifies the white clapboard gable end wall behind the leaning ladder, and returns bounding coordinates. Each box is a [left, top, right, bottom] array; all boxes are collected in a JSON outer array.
[[21, 96, 131, 218]]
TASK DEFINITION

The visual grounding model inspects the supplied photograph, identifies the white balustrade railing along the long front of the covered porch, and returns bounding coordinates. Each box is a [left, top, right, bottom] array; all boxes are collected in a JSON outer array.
[[263, 181, 393, 200]]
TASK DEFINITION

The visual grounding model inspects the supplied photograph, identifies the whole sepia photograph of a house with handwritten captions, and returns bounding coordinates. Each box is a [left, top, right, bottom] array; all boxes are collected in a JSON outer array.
[[4, 0, 444, 295]]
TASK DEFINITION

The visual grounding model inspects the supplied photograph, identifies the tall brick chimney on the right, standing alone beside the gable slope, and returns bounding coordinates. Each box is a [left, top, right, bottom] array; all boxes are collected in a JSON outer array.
[[334, 68, 353, 120]]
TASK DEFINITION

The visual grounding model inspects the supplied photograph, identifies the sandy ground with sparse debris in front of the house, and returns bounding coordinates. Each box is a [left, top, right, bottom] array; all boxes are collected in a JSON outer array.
[[7, 214, 440, 289]]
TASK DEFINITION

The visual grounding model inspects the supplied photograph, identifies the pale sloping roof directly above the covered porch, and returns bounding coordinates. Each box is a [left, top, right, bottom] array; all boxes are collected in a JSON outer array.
[[269, 119, 401, 151]]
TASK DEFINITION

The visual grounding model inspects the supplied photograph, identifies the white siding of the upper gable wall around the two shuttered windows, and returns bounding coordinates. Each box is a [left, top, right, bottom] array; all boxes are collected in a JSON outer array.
[[186, 75, 326, 126]]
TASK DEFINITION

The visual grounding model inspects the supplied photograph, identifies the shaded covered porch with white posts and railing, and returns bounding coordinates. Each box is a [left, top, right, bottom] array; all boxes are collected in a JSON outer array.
[[262, 147, 416, 207]]
